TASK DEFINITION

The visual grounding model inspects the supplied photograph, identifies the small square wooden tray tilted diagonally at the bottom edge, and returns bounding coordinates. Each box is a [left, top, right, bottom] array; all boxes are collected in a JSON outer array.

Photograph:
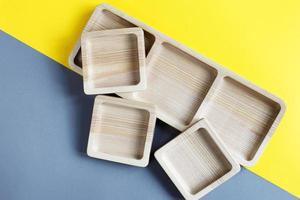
[[155, 120, 240, 199]]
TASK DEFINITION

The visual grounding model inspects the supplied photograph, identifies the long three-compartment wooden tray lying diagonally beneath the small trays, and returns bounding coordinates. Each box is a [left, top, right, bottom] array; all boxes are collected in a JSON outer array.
[[69, 4, 285, 166]]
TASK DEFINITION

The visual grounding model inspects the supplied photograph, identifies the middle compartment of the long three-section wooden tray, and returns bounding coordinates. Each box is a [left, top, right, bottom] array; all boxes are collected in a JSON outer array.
[[132, 43, 216, 126]]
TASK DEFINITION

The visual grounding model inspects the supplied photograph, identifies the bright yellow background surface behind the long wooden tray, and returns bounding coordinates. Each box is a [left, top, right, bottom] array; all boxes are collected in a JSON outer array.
[[0, 0, 300, 197]]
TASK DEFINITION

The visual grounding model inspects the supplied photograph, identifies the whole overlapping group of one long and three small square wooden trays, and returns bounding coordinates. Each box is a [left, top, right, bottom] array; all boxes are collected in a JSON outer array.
[[69, 4, 285, 199]]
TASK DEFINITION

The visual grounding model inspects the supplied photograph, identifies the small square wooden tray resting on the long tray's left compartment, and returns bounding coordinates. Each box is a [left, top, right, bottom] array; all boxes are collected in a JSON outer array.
[[81, 28, 146, 94]]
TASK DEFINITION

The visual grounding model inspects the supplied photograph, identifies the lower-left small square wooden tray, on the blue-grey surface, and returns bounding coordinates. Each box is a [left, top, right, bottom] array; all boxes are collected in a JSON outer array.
[[87, 95, 156, 167]]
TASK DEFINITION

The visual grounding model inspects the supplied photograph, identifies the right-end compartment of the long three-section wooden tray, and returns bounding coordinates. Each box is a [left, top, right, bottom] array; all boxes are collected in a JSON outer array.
[[203, 77, 281, 165]]
